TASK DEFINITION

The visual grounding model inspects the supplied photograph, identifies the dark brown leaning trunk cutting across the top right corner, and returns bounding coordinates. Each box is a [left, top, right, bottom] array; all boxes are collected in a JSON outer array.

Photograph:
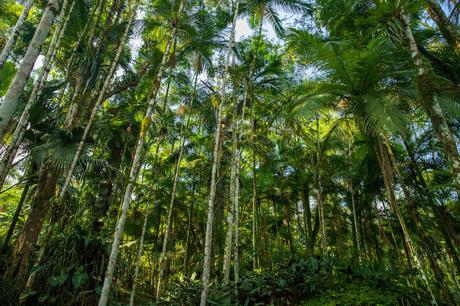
[[426, 0, 460, 56]]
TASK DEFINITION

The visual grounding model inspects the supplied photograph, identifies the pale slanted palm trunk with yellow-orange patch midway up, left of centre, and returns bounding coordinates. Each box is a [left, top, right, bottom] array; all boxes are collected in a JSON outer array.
[[99, 22, 178, 306]]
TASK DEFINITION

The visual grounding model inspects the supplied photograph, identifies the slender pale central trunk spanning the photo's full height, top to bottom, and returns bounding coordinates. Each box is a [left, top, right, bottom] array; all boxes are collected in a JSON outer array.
[[200, 0, 239, 306]]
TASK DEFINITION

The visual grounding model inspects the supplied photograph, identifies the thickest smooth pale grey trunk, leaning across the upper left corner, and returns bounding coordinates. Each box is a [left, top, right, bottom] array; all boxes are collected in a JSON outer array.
[[0, 0, 59, 143]]
